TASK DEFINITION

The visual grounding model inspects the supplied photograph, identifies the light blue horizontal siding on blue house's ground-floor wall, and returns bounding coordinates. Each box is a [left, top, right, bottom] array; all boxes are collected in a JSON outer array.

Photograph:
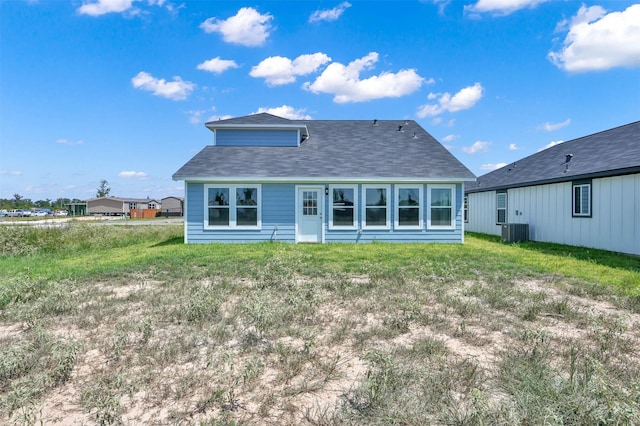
[[185, 182, 463, 244]]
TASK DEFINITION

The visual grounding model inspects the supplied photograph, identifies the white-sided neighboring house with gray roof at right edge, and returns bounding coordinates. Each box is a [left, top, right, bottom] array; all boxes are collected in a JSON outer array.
[[465, 121, 640, 255]]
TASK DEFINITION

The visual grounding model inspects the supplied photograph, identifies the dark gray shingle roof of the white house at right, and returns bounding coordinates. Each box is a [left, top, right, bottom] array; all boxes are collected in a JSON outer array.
[[465, 121, 640, 192]]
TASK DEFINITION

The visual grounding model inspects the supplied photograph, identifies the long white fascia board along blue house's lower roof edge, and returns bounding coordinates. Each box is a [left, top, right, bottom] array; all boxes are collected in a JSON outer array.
[[173, 176, 476, 183]]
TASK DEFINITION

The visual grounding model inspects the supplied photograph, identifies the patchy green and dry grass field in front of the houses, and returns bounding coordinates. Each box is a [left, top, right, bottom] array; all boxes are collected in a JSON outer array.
[[0, 223, 640, 425]]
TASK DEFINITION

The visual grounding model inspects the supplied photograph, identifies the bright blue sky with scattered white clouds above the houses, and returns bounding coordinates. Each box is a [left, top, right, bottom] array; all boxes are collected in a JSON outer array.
[[0, 0, 640, 201]]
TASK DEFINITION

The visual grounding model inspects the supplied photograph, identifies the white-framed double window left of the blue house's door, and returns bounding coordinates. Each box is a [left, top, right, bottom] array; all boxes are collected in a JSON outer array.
[[205, 185, 261, 229]]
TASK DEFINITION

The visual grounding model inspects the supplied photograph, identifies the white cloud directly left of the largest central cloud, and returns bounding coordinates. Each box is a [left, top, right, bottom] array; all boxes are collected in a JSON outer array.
[[249, 52, 331, 86]]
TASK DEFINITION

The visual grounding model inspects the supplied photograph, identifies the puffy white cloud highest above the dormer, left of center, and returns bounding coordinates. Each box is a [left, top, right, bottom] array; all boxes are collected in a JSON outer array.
[[200, 7, 273, 47]]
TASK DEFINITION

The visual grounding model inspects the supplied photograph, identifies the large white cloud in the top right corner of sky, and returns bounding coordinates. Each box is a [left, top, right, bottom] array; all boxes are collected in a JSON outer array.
[[548, 4, 640, 72]]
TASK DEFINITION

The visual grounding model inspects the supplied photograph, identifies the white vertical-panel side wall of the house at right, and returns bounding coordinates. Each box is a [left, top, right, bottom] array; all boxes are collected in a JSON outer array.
[[466, 174, 640, 255]]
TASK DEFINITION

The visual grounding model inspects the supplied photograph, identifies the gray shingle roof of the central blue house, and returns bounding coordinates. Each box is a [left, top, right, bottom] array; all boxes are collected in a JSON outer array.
[[173, 114, 475, 180]]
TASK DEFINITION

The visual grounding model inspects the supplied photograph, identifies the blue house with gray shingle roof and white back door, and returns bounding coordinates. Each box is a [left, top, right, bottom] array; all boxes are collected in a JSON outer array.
[[173, 113, 475, 243]]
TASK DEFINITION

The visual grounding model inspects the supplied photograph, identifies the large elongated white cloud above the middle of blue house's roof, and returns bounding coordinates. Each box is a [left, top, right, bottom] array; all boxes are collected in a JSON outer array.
[[303, 52, 433, 103]]
